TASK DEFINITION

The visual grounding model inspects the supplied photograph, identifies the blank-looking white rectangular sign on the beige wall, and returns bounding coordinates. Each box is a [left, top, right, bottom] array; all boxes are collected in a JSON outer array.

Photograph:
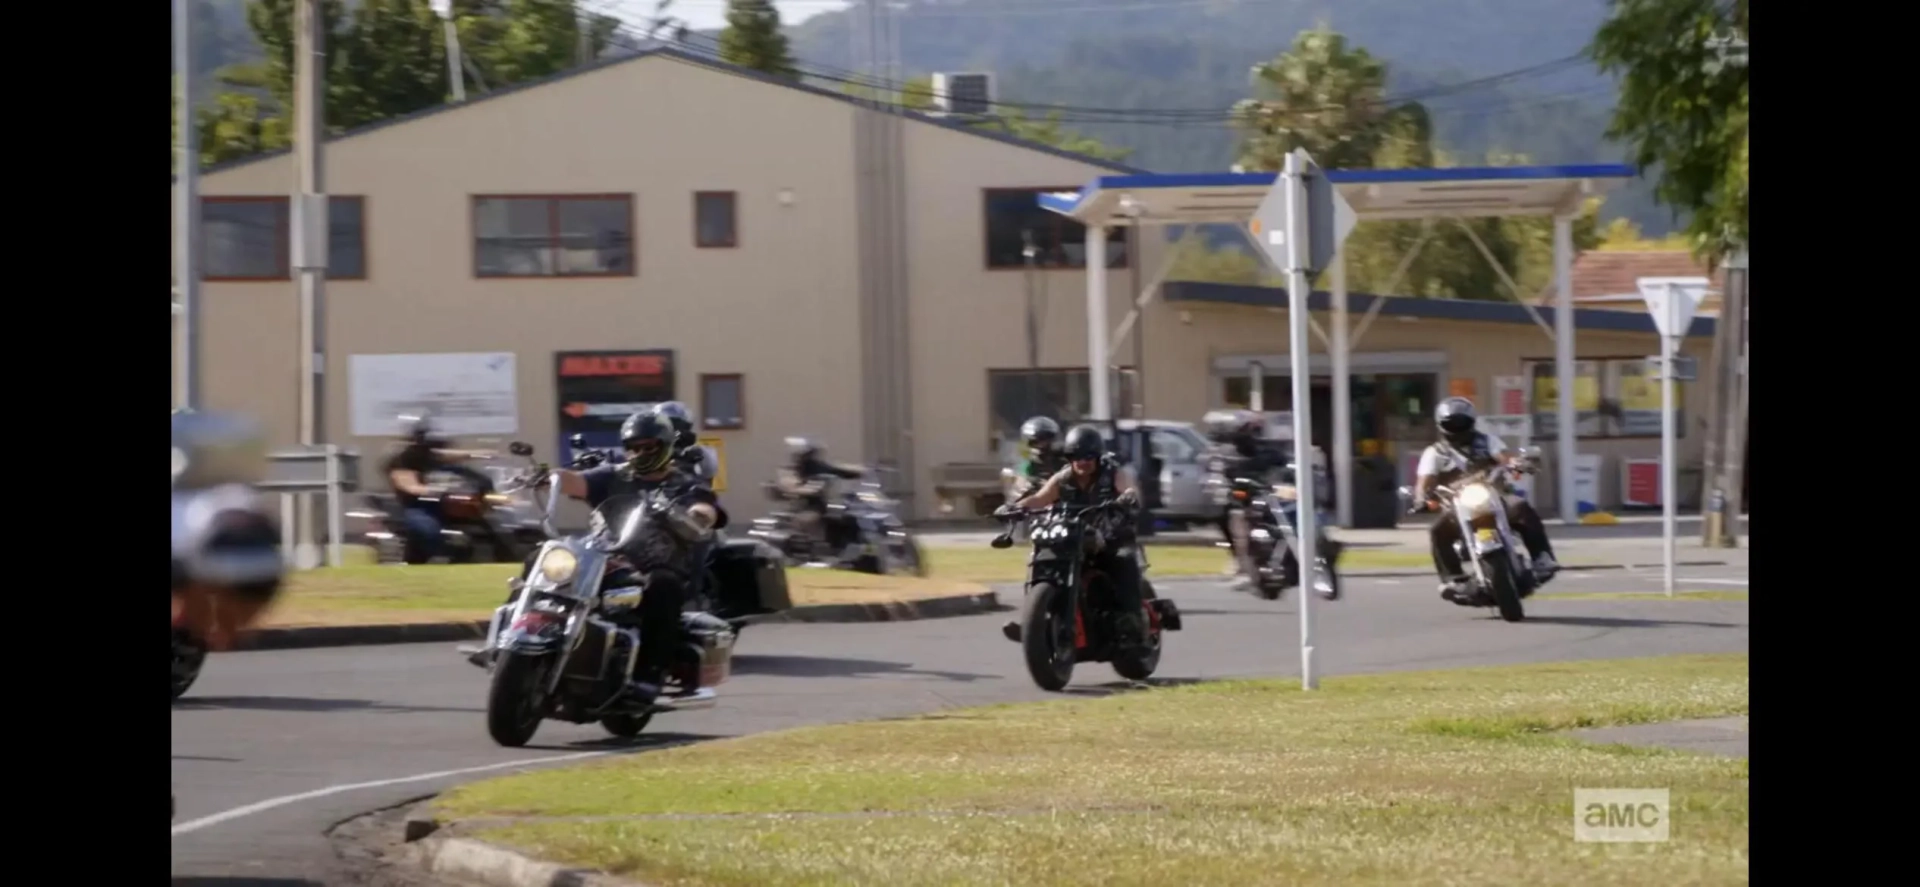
[[348, 351, 520, 438]]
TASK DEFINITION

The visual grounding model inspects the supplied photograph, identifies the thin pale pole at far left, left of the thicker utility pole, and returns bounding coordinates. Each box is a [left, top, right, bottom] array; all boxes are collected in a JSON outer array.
[[173, 0, 205, 409]]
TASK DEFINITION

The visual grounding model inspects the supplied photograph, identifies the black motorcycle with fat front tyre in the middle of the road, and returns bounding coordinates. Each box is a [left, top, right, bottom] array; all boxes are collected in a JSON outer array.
[[993, 503, 1181, 691]]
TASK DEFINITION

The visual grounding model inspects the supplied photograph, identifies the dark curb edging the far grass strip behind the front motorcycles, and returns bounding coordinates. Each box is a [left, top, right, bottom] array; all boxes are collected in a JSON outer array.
[[234, 591, 1004, 651]]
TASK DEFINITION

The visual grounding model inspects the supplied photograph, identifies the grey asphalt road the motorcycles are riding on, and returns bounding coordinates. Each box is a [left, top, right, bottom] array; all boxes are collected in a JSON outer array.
[[173, 566, 1747, 885]]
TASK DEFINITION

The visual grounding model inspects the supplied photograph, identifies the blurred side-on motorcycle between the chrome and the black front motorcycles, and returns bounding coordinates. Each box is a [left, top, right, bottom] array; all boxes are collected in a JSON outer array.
[[747, 470, 927, 576]]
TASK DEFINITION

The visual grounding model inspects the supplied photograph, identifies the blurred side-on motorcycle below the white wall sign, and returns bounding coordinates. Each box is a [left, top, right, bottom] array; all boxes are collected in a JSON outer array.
[[346, 460, 543, 564]]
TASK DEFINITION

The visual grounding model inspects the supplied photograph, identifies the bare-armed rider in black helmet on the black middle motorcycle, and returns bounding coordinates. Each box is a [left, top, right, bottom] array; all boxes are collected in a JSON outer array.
[[998, 424, 1146, 647]]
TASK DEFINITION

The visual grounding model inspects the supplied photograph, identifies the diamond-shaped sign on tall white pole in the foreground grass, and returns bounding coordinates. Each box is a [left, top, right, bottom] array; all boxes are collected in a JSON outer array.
[[1246, 148, 1359, 689]]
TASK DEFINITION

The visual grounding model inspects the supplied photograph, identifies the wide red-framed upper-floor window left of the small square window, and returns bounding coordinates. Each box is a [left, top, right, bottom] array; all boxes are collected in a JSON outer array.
[[474, 194, 634, 276]]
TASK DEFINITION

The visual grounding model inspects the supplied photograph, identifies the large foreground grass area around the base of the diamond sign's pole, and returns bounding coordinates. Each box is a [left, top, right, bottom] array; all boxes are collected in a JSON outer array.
[[436, 655, 1747, 887]]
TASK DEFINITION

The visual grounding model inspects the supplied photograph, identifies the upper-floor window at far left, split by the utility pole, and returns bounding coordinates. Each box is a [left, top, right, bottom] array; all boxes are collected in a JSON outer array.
[[200, 196, 367, 280]]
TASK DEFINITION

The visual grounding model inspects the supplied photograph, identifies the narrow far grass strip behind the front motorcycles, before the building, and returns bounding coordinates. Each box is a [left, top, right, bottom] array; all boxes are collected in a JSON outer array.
[[265, 545, 1427, 628]]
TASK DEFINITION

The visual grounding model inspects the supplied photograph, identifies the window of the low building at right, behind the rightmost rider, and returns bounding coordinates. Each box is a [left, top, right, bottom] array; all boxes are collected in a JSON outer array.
[[1521, 357, 1688, 440]]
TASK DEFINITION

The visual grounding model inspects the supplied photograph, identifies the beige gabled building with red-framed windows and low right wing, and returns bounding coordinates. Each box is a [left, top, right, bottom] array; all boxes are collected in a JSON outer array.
[[175, 50, 1705, 516]]
